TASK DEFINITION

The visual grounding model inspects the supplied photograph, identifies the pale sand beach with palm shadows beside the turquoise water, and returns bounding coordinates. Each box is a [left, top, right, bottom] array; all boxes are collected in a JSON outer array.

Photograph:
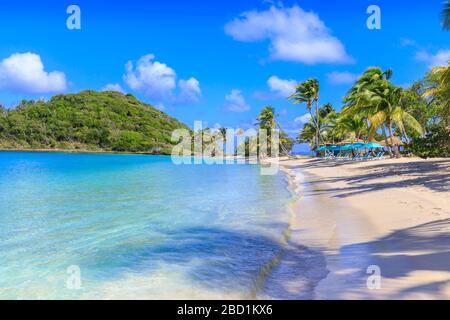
[[281, 158, 450, 299]]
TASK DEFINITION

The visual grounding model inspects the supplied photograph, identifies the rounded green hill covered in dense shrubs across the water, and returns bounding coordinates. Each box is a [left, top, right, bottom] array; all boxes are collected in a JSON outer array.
[[0, 91, 189, 154]]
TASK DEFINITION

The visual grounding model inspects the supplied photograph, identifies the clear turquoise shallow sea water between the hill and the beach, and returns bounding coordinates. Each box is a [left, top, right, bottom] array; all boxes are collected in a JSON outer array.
[[0, 152, 291, 299]]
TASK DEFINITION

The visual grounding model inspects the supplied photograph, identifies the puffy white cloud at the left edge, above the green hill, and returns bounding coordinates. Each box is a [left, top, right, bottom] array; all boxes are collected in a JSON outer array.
[[0, 52, 67, 94]]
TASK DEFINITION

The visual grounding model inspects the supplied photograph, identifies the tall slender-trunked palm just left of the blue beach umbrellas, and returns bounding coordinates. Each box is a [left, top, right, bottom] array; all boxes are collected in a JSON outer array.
[[288, 78, 320, 146]]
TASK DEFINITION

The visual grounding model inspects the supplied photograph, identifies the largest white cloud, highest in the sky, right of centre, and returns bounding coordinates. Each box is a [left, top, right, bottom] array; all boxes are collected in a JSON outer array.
[[225, 5, 353, 64]]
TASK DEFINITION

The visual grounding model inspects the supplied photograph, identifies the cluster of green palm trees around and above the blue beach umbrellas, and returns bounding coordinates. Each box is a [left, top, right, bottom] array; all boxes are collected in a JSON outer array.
[[288, 65, 450, 158]]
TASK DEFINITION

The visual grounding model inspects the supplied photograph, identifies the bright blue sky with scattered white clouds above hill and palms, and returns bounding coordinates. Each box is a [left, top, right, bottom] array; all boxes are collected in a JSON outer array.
[[0, 0, 450, 144]]
